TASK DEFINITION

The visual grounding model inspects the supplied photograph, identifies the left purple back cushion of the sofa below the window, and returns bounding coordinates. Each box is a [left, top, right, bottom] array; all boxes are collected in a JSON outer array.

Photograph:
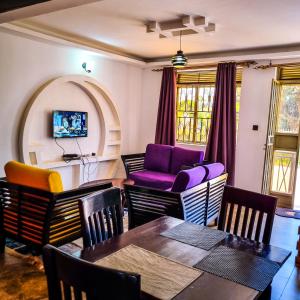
[[144, 144, 173, 173]]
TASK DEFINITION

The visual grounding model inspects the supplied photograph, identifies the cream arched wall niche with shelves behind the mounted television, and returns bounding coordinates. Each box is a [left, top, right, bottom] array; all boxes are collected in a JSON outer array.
[[19, 75, 121, 187]]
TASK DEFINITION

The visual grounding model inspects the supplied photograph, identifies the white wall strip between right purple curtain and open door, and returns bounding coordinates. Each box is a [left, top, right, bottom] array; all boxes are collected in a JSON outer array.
[[235, 68, 275, 192]]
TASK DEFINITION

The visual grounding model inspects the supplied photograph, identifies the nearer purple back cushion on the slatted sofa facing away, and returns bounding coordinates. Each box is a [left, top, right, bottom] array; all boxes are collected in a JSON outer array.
[[171, 166, 206, 193]]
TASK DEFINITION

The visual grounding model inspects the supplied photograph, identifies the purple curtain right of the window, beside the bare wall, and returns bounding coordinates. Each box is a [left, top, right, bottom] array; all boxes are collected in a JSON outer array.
[[205, 62, 236, 185]]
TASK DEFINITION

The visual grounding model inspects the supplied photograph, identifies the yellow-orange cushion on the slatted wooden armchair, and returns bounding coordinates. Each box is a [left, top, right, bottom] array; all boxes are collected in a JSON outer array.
[[4, 161, 63, 193]]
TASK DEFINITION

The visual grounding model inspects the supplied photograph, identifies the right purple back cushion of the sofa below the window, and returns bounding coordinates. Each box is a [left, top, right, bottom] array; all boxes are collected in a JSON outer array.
[[171, 147, 204, 174]]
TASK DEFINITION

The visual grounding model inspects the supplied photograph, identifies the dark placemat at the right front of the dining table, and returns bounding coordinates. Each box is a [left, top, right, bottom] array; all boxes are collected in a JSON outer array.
[[195, 246, 280, 292]]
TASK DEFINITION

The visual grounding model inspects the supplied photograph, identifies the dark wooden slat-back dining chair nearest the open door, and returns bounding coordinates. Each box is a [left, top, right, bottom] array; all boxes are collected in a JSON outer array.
[[218, 186, 277, 244]]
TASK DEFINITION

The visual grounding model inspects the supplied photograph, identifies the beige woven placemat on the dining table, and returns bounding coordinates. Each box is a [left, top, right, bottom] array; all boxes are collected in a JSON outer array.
[[96, 245, 203, 300]]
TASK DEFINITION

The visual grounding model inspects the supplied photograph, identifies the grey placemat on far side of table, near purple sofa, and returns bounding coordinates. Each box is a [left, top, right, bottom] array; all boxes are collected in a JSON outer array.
[[161, 222, 227, 250]]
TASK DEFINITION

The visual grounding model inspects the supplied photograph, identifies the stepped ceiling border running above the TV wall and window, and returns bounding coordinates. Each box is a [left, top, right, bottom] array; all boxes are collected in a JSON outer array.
[[0, 20, 300, 67]]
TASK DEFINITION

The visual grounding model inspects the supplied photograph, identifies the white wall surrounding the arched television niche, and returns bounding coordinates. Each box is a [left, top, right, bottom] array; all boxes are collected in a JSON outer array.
[[0, 32, 143, 183]]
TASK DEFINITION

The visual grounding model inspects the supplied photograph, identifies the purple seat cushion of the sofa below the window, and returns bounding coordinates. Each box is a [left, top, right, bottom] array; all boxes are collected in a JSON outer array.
[[129, 170, 176, 190]]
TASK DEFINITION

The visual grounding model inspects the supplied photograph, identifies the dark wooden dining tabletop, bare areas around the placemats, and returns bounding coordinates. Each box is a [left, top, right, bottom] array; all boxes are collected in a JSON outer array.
[[79, 216, 290, 300]]
